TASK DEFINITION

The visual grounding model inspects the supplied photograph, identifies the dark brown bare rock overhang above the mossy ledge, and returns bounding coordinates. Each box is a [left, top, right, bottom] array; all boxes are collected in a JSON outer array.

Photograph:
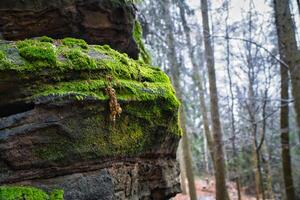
[[0, 0, 138, 59]]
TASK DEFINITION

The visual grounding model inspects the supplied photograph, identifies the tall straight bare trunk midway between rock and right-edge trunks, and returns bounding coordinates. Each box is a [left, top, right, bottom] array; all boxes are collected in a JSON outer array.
[[201, 0, 229, 200]]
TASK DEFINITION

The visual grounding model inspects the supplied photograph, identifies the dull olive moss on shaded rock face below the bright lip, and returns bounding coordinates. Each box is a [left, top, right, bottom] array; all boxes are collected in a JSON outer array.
[[35, 101, 180, 164]]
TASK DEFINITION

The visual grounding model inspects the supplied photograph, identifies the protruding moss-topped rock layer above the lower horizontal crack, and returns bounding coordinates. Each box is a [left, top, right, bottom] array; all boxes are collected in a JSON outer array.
[[0, 37, 181, 180]]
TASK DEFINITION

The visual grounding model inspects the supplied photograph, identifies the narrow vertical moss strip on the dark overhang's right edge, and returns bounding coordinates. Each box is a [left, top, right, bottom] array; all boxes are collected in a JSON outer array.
[[133, 21, 152, 64]]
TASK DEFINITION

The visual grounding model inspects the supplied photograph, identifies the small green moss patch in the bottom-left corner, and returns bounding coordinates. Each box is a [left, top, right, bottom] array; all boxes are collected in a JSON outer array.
[[0, 186, 63, 200]]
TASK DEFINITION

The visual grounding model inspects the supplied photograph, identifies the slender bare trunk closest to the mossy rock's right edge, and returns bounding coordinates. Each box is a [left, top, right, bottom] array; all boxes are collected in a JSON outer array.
[[162, 0, 197, 200]]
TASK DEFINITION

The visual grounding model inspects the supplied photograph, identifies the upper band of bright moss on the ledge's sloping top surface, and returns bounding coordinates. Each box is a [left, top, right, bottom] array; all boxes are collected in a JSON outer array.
[[0, 38, 169, 83]]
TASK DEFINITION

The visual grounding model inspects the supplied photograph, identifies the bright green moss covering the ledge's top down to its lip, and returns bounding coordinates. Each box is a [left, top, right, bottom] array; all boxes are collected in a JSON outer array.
[[0, 37, 179, 108]]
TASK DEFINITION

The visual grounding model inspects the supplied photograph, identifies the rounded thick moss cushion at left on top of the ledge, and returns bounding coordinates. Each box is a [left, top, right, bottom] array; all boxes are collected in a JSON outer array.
[[17, 40, 56, 67]]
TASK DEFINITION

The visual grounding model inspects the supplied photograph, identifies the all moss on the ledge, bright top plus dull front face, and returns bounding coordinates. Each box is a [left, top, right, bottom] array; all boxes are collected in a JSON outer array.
[[0, 38, 180, 159]]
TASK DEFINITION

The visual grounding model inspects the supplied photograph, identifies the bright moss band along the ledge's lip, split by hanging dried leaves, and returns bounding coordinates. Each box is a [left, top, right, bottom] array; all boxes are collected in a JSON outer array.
[[36, 80, 179, 109]]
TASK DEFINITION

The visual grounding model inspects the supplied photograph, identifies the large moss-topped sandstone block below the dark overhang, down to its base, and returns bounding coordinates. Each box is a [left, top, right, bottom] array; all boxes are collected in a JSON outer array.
[[0, 37, 180, 200]]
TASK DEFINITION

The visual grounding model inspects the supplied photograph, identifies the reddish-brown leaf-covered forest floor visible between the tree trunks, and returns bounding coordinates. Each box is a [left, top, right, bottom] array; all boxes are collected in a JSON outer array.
[[174, 179, 255, 200]]
